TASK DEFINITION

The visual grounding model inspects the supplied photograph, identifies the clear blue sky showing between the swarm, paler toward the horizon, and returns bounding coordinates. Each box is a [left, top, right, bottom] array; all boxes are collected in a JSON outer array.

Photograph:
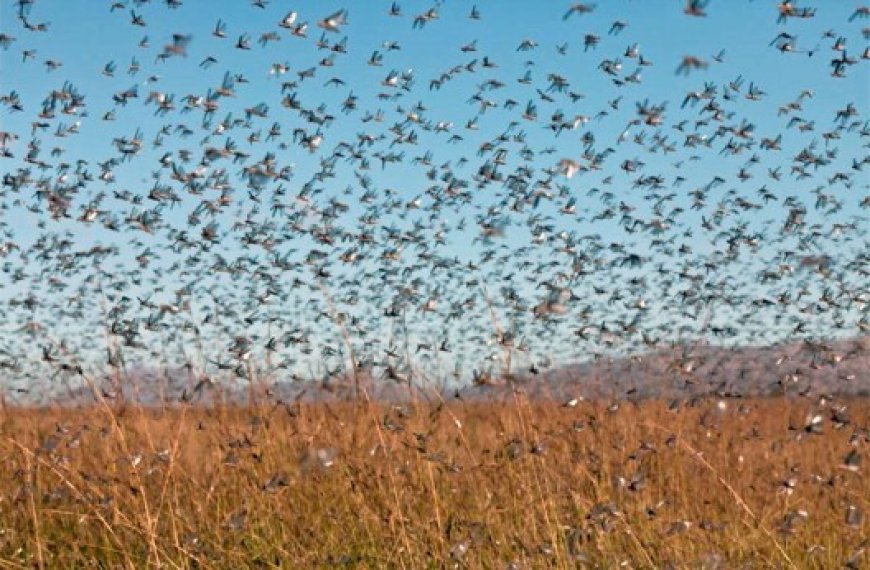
[[0, 0, 870, 400]]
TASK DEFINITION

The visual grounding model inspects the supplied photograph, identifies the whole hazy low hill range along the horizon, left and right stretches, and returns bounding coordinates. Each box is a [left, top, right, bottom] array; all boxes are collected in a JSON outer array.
[[22, 337, 870, 405]]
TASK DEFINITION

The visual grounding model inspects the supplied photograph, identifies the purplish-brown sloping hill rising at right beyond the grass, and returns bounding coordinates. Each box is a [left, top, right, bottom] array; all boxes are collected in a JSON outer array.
[[471, 337, 870, 399]]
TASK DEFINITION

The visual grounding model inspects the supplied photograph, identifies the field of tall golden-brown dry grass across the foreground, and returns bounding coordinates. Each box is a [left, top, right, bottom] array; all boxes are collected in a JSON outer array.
[[0, 395, 870, 568]]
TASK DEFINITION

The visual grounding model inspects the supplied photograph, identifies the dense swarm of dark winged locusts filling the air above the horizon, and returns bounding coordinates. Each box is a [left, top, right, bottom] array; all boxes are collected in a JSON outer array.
[[0, 0, 870, 399]]
